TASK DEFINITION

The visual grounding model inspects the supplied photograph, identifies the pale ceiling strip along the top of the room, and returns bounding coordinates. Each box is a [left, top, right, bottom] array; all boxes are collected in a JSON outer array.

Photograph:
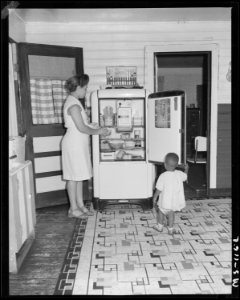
[[15, 7, 231, 23]]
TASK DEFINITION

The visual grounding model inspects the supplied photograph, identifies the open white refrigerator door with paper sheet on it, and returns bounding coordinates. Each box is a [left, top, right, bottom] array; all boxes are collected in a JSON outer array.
[[148, 91, 186, 164]]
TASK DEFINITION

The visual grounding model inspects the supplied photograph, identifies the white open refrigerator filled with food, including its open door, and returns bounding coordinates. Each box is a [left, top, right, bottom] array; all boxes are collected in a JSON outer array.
[[91, 88, 186, 210]]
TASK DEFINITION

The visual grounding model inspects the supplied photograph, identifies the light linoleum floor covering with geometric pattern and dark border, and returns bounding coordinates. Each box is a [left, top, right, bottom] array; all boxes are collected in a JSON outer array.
[[55, 198, 232, 295]]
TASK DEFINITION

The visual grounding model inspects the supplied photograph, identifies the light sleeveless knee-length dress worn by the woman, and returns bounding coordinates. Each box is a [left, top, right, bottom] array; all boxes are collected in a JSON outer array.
[[62, 95, 92, 181]]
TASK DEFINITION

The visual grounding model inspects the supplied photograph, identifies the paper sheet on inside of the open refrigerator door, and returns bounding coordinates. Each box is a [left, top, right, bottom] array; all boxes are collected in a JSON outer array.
[[155, 98, 171, 128]]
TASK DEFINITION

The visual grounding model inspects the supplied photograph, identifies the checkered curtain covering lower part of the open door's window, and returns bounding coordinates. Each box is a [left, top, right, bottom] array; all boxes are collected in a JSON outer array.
[[30, 79, 67, 124]]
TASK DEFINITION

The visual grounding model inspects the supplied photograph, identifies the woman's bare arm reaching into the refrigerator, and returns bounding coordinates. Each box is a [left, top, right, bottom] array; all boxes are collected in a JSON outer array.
[[68, 104, 108, 135]]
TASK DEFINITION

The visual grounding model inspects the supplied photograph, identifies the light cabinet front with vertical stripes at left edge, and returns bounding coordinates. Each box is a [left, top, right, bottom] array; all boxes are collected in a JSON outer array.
[[9, 161, 36, 273]]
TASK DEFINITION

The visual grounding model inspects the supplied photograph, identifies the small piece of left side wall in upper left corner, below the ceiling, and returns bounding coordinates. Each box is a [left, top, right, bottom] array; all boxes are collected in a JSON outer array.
[[9, 9, 25, 42]]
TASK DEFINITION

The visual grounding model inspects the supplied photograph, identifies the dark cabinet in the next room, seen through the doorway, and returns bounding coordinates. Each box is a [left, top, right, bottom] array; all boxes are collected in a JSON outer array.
[[186, 108, 201, 157]]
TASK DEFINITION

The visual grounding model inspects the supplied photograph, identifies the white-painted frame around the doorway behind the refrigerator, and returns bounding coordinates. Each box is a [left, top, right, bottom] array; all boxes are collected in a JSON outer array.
[[144, 42, 219, 193]]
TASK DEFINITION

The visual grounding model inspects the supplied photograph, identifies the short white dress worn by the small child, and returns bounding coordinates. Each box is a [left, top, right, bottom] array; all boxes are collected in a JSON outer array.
[[156, 170, 187, 211]]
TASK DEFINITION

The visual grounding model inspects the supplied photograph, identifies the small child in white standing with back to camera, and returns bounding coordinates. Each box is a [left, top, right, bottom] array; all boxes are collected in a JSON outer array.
[[153, 153, 188, 235]]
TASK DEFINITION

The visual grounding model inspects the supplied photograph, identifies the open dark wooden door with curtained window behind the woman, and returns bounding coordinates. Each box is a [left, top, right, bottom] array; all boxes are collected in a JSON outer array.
[[18, 43, 83, 208]]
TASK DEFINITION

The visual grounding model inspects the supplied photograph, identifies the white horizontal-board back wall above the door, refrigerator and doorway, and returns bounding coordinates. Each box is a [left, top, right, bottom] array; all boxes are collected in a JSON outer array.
[[23, 21, 231, 103]]
